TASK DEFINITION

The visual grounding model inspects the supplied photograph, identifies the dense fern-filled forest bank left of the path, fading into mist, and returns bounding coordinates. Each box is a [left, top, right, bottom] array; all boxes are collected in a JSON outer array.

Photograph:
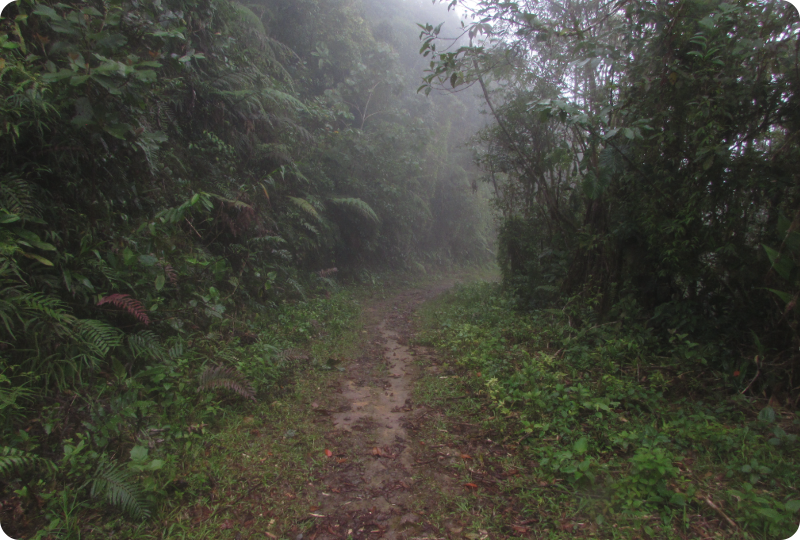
[[0, 0, 492, 535]]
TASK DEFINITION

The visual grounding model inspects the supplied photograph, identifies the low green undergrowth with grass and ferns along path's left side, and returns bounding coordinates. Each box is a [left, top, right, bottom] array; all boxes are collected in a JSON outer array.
[[0, 290, 362, 538]]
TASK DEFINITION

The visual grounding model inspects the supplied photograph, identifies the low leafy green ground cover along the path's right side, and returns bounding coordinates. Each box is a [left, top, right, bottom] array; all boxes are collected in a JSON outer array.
[[417, 283, 800, 538]]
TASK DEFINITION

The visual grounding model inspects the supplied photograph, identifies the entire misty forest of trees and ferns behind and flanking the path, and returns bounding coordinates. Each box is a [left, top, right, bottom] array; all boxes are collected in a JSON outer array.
[[0, 0, 800, 527]]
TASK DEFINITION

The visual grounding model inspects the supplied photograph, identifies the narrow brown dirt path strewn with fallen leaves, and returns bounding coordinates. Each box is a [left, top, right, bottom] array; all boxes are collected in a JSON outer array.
[[306, 283, 452, 540]]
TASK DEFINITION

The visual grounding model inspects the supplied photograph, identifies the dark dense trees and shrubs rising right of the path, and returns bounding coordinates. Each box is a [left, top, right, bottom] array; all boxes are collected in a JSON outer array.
[[423, 0, 800, 396]]
